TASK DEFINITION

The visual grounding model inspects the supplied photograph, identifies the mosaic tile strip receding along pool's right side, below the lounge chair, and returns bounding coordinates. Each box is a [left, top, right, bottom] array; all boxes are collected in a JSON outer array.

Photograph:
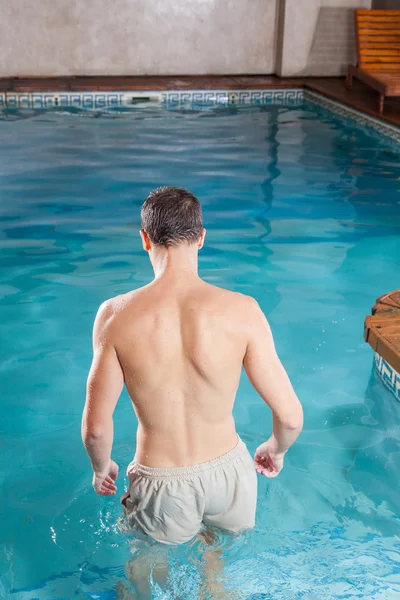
[[304, 90, 400, 143]]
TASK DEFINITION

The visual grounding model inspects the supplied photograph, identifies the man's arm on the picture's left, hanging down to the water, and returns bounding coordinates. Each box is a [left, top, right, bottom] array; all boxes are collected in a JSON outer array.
[[82, 302, 124, 496]]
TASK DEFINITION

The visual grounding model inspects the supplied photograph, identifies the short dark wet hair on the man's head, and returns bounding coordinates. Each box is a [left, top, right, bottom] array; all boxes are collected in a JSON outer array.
[[141, 187, 203, 248]]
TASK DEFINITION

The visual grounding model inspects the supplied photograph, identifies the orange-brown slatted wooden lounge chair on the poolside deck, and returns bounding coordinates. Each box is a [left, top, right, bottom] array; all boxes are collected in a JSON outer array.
[[347, 10, 400, 114]]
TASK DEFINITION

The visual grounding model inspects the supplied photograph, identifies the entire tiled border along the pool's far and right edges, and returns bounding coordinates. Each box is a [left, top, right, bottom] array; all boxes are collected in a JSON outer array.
[[0, 87, 400, 143]]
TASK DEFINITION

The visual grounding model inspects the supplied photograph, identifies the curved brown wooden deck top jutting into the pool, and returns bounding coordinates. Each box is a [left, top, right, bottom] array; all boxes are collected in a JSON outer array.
[[364, 289, 400, 373]]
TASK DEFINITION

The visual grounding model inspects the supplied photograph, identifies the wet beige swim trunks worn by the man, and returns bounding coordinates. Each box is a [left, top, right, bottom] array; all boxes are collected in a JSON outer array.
[[121, 439, 257, 544]]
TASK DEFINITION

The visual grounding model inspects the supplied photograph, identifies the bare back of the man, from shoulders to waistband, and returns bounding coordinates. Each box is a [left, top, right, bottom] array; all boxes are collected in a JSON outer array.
[[107, 275, 251, 467]]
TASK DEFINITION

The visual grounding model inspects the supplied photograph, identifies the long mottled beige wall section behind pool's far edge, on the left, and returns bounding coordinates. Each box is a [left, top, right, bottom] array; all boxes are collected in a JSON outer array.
[[0, 0, 278, 76]]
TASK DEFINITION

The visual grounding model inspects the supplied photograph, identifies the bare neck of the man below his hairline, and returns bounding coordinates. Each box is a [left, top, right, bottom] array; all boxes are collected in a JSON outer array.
[[151, 244, 198, 279]]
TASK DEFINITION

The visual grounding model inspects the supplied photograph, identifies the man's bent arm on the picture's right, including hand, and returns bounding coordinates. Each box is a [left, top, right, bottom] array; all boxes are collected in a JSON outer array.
[[244, 300, 303, 477]]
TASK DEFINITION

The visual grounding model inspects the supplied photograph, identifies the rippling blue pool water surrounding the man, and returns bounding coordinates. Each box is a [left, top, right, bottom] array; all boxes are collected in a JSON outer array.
[[0, 104, 400, 600]]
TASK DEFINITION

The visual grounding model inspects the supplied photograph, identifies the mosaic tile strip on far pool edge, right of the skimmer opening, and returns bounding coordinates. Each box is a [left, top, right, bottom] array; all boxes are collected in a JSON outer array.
[[161, 88, 304, 106]]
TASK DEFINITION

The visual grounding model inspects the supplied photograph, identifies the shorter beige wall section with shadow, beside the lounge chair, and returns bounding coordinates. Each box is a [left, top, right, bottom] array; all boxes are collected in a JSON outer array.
[[277, 0, 374, 77]]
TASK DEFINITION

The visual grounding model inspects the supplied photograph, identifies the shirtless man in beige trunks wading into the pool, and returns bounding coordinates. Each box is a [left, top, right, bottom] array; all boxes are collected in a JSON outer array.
[[82, 187, 303, 544]]
